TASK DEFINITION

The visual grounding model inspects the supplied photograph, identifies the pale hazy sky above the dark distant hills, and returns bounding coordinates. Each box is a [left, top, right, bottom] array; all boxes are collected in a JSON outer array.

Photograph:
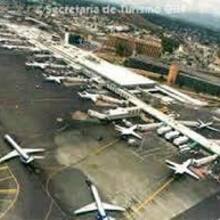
[[112, 0, 220, 15]]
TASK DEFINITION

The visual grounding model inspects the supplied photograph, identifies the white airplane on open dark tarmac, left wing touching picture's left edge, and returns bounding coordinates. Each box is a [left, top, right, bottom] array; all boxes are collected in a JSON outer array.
[[0, 134, 45, 164]]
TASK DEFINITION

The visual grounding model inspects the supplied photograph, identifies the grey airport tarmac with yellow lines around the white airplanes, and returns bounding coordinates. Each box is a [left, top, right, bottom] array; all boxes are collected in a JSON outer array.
[[0, 50, 219, 220]]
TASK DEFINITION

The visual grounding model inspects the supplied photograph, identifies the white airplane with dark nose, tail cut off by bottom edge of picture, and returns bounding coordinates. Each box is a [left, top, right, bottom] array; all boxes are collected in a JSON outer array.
[[74, 180, 125, 220]]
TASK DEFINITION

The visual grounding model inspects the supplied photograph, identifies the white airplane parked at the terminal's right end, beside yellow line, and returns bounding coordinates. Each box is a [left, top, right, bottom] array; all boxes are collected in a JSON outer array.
[[166, 159, 200, 180]]
